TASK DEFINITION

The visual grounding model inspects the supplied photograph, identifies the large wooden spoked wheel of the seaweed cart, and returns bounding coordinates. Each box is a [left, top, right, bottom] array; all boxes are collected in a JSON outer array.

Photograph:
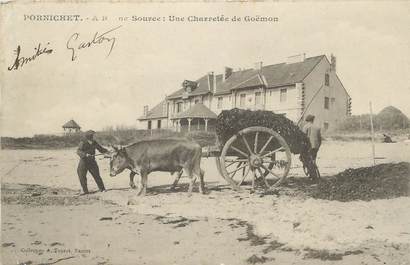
[[219, 127, 291, 190]]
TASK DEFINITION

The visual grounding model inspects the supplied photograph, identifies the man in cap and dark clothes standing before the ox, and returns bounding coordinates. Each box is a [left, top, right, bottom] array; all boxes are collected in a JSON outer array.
[[77, 130, 108, 194]]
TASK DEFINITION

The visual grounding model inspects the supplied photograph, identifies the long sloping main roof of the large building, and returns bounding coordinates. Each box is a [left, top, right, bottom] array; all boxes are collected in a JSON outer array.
[[167, 55, 326, 99]]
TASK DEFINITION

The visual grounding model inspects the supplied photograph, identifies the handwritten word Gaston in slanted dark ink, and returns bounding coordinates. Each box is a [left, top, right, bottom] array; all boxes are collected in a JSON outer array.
[[66, 26, 122, 61]]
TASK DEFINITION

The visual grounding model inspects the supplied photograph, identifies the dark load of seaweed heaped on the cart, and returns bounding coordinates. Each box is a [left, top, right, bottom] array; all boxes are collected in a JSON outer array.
[[216, 108, 317, 177]]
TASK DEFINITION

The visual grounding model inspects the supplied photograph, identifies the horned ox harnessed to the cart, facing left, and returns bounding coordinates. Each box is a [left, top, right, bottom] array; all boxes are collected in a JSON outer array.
[[110, 139, 204, 195]]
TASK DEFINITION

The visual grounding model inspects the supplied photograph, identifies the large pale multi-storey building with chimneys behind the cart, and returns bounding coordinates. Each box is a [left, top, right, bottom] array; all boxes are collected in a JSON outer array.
[[138, 54, 351, 131]]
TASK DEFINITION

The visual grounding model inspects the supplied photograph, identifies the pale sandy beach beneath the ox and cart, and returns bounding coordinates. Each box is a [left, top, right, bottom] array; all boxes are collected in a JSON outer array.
[[1, 142, 410, 265]]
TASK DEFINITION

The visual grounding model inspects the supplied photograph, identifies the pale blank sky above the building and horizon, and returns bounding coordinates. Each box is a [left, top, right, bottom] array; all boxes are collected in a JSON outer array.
[[0, 1, 410, 137]]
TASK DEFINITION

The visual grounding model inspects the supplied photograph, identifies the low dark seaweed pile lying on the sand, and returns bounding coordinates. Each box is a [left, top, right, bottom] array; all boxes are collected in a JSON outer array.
[[311, 162, 410, 202]]
